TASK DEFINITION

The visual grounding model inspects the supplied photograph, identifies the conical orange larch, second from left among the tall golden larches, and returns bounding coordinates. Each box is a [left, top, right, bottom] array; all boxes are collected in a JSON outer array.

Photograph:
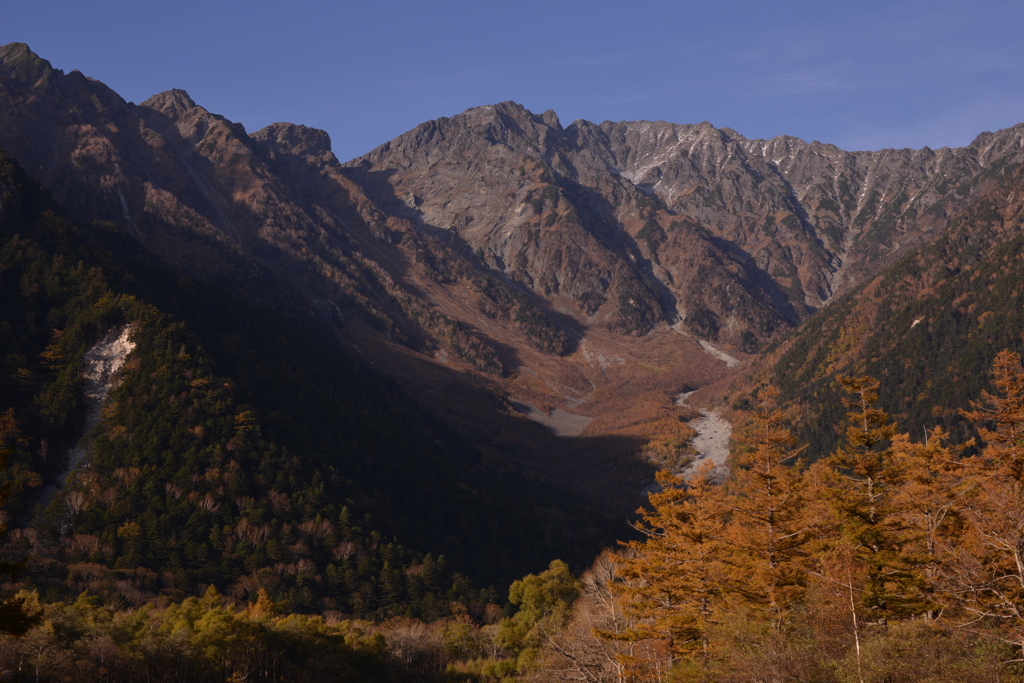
[[726, 387, 820, 628]]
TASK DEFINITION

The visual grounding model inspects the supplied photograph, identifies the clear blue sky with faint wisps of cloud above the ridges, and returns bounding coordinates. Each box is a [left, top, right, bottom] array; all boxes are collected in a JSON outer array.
[[0, 0, 1024, 160]]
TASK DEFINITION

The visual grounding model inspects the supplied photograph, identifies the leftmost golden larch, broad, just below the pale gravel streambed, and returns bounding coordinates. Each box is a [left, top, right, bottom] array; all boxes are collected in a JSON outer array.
[[617, 462, 729, 664]]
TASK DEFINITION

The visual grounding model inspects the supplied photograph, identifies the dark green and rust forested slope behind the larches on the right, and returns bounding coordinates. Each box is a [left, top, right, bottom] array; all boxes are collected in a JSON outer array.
[[749, 164, 1024, 458]]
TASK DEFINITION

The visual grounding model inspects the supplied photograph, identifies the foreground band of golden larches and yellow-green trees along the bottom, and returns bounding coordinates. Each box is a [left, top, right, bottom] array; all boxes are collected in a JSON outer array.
[[8, 358, 1024, 683]]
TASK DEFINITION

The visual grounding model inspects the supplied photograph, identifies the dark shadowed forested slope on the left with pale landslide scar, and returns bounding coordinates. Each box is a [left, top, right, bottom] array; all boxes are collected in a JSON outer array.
[[0, 149, 608, 617]]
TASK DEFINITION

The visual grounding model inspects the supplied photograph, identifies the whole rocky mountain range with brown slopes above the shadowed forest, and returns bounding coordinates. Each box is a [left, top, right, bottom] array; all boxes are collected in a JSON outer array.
[[0, 43, 1024, 598]]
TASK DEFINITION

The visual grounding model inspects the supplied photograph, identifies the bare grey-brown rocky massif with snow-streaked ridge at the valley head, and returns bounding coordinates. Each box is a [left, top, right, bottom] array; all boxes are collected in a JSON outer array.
[[346, 102, 1024, 347]]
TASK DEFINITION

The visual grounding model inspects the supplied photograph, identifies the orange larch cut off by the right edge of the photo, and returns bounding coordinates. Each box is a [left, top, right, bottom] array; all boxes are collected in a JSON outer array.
[[942, 351, 1024, 649]]
